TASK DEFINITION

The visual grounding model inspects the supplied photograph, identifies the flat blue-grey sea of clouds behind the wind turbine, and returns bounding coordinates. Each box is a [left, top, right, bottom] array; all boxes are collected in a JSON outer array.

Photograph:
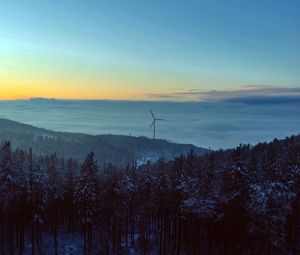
[[0, 86, 300, 149]]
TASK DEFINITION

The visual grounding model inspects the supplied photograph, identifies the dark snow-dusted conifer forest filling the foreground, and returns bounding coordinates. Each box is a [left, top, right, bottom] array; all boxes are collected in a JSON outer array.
[[0, 136, 300, 255]]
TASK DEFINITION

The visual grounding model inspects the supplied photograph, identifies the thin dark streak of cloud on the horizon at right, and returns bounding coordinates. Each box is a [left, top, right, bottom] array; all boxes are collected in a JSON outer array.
[[145, 85, 300, 104]]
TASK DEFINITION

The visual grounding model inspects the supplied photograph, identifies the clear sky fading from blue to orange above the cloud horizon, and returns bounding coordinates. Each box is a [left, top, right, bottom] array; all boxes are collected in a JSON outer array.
[[0, 0, 300, 99]]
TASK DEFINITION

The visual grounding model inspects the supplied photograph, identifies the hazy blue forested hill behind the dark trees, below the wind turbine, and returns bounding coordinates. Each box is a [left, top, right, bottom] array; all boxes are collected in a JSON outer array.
[[0, 119, 208, 166]]
